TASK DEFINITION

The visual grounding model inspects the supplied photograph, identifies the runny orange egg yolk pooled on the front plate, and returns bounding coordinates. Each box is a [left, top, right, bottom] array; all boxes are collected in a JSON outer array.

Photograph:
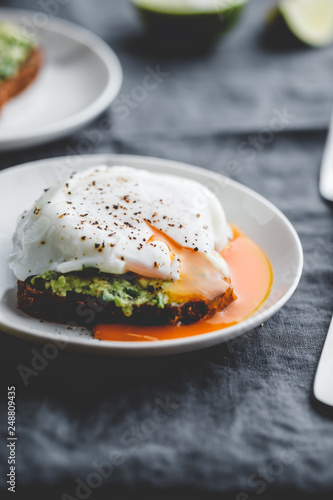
[[93, 227, 273, 341]]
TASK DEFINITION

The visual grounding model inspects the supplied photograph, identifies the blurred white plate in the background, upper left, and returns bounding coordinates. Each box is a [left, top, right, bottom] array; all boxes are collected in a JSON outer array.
[[0, 9, 122, 151]]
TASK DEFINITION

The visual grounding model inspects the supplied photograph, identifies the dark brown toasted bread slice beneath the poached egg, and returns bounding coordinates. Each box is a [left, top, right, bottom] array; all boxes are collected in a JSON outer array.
[[17, 280, 236, 328]]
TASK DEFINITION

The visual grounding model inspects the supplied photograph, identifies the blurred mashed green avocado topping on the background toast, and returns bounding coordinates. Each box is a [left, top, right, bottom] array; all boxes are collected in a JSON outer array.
[[0, 22, 36, 83]]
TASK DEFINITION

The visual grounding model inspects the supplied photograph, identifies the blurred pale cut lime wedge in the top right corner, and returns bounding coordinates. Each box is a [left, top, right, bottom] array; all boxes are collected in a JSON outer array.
[[268, 0, 333, 47]]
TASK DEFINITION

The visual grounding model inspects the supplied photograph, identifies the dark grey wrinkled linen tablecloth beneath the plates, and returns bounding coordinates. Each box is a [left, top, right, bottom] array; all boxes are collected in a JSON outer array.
[[0, 0, 333, 500]]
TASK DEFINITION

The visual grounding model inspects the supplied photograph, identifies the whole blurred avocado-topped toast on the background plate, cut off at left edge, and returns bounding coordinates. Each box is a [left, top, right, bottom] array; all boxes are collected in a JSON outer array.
[[0, 22, 43, 109]]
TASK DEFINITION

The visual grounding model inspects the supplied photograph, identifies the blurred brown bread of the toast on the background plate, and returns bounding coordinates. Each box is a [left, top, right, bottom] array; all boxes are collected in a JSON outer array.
[[0, 48, 43, 108]]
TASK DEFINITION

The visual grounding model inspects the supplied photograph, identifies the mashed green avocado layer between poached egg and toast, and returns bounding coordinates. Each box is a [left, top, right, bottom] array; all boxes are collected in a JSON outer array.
[[30, 269, 169, 316]]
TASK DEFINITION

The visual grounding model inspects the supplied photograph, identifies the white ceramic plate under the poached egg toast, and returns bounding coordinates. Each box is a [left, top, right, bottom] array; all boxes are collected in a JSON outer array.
[[0, 155, 303, 356]]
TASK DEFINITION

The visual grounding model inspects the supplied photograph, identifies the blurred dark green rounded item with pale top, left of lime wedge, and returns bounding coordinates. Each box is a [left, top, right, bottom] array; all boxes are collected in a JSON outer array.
[[132, 0, 247, 46]]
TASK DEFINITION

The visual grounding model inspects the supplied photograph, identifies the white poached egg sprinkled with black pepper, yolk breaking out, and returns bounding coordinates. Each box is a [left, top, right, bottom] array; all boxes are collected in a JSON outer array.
[[10, 165, 231, 298]]
